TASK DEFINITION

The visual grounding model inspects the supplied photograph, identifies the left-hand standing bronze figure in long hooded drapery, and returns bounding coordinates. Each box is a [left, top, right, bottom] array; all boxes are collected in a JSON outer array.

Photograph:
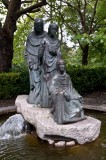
[[25, 18, 46, 105]]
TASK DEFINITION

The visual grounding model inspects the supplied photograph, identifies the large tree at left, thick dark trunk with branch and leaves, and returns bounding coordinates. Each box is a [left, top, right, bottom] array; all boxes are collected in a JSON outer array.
[[0, 0, 47, 72]]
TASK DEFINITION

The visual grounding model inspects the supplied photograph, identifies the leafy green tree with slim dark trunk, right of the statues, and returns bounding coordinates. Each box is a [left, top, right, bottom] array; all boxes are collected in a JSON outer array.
[[46, 0, 106, 65]]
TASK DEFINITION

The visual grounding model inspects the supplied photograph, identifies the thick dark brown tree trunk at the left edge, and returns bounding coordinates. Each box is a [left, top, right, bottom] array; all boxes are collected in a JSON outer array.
[[0, 0, 21, 72]]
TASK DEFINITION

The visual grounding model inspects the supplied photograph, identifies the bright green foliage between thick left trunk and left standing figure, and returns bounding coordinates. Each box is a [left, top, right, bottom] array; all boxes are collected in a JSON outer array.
[[12, 17, 33, 67]]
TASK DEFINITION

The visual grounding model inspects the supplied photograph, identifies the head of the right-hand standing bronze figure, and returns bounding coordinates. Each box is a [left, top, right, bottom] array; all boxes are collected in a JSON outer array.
[[48, 23, 58, 37]]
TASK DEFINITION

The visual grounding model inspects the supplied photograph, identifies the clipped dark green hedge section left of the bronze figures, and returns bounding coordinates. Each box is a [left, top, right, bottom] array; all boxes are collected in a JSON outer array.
[[0, 71, 29, 99]]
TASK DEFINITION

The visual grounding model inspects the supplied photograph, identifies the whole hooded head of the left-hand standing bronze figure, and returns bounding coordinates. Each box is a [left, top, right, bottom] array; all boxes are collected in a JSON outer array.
[[34, 18, 44, 34]]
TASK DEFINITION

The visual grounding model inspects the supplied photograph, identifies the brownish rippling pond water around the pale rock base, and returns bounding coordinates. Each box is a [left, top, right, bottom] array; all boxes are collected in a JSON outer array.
[[0, 111, 106, 160]]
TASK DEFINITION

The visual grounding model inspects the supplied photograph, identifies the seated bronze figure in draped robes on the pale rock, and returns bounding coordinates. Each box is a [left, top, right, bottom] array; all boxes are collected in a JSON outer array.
[[49, 60, 86, 124]]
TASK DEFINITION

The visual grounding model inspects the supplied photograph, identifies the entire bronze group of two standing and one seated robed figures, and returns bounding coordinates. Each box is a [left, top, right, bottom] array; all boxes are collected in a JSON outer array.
[[25, 19, 86, 124]]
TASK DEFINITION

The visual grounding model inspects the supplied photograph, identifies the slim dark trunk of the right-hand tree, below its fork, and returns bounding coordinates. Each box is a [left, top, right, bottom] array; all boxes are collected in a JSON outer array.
[[82, 44, 89, 66]]
